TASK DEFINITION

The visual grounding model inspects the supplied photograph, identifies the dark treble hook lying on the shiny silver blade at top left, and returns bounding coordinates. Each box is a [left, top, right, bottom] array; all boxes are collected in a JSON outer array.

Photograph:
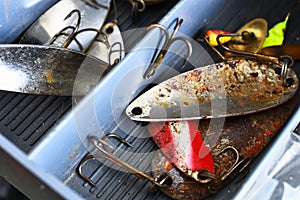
[[50, 9, 81, 48]]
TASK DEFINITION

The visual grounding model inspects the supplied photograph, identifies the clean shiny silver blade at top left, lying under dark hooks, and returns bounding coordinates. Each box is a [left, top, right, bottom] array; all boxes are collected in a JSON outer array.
[[20, 0, 110, 50]]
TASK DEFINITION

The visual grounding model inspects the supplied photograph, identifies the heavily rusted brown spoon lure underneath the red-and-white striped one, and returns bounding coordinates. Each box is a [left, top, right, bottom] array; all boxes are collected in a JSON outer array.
[[152, 89, 300, 199]]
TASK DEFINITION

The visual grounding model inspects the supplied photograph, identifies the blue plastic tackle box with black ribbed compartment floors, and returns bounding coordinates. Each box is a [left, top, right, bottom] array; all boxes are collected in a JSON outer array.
[[0, 0, 300, 199]]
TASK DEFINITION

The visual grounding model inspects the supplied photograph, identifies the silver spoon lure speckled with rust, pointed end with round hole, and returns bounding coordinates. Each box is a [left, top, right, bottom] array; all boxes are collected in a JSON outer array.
[[126, 59, 298, 121]]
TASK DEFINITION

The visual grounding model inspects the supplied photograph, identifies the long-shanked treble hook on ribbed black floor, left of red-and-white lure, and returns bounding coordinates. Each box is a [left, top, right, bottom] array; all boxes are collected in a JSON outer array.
[[78, 133, 171, 187]]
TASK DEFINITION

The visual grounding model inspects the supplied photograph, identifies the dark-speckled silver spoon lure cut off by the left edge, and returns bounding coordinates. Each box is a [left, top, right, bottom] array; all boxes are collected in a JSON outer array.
[[0, 45, 107, 96]]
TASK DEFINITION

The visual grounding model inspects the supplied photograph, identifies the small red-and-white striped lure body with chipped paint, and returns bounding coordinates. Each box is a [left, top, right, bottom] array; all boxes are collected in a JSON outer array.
[[148, 121, 214, 173]]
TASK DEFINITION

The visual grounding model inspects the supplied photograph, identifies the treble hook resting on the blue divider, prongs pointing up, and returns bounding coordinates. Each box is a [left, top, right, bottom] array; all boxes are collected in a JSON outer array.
[[143, 19, 192, 79]]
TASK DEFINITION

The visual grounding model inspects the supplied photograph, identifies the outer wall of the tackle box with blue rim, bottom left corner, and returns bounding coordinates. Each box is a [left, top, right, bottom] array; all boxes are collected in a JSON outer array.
[[0, 134, 81, 199]]
